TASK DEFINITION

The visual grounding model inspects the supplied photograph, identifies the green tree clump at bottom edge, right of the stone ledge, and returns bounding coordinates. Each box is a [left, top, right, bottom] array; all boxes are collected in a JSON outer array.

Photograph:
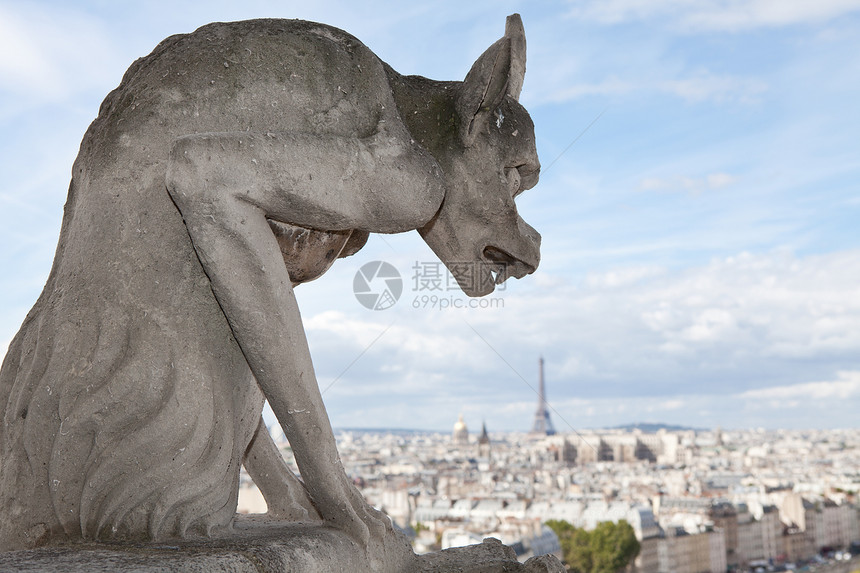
[[546, 519, 639, 573]]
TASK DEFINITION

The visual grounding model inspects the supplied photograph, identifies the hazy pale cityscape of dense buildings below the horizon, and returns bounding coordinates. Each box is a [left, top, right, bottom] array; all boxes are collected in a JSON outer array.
[[240, 418, 860, 573]]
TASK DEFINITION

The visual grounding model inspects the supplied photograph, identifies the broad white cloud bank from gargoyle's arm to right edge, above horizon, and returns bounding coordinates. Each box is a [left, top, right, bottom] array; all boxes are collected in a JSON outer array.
[[296, 250, 860, 427]]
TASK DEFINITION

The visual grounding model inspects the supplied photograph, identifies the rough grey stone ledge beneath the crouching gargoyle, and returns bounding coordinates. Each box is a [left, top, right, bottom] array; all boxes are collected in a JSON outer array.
[[0, 521, 564, 573]]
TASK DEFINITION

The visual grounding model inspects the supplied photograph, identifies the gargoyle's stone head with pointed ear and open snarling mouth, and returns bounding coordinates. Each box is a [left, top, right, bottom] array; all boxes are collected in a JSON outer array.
[[418, 14, 540, 296]]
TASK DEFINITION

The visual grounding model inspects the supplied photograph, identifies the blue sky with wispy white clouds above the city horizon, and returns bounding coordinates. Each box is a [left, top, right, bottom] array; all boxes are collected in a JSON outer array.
[[0, 0, 860, 431]]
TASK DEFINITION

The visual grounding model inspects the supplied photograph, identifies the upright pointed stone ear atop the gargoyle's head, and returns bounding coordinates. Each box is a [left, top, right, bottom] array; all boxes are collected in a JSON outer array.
[[457, 14, 526, 145]]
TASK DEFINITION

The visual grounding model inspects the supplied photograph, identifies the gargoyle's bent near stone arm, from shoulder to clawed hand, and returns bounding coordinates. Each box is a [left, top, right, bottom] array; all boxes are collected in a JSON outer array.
[[166, 127, 444, 543]]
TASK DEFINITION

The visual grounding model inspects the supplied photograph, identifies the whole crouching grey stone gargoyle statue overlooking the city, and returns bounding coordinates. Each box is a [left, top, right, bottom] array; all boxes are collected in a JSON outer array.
[[0, 15, 540, 559]]
